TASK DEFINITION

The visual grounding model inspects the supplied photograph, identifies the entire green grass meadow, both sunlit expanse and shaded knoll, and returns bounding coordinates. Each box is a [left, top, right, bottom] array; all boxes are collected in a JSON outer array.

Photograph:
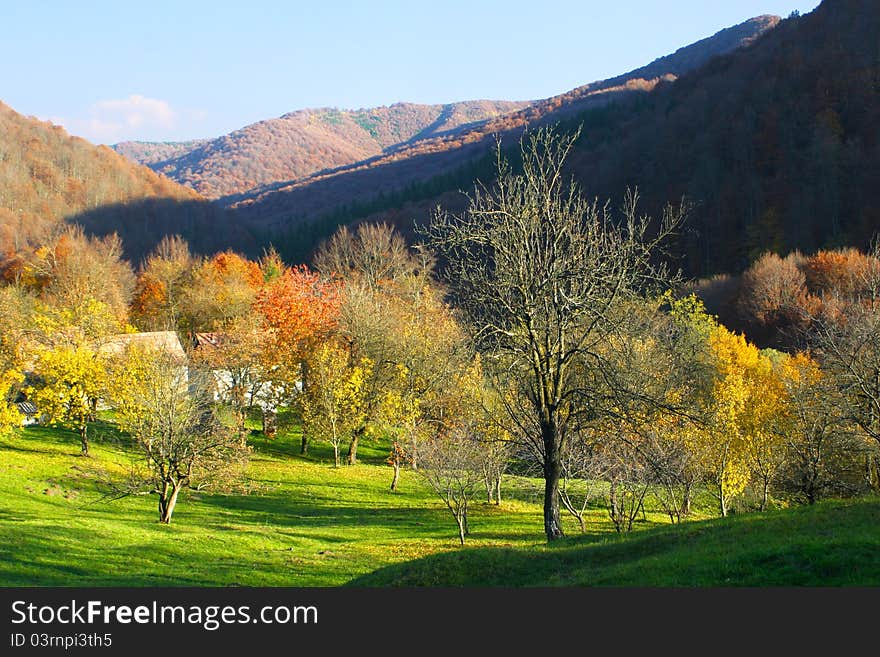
[[0, 424, 880, 586]]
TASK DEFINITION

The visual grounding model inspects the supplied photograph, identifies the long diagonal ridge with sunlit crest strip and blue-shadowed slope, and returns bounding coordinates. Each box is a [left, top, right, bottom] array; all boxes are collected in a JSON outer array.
[[230, 16, 780, 251]]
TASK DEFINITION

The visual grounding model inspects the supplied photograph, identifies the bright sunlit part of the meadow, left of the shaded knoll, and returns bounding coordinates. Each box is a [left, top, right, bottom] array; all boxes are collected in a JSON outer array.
[[0, 427, 564, 586]]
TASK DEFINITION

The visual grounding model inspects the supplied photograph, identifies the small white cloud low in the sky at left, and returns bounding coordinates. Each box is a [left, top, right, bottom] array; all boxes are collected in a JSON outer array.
[[52, 94, 179, 144]]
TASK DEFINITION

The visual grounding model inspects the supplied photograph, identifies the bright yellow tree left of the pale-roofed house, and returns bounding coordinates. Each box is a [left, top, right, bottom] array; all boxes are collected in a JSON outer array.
[[28, 345, 108, 456]]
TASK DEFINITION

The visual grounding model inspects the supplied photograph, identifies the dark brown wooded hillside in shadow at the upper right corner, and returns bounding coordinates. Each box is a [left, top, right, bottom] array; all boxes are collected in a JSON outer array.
[[556, 0, 880, 276]]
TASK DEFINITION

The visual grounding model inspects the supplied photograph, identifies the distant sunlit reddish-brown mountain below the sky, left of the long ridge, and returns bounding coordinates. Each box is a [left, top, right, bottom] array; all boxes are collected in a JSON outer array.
[[113, 100, 528, 199]]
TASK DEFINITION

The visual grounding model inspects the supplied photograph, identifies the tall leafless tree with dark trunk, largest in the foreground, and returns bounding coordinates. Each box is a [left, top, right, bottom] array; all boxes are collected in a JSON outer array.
[[425, 128, 684, 540]]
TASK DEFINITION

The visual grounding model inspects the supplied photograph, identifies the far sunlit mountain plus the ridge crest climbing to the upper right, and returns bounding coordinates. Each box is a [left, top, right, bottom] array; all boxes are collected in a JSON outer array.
[[113, 15, 780, 205]]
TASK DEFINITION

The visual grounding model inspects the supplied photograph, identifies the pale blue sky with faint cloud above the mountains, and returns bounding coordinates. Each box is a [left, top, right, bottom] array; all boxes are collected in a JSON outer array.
[[0, 0, 818, 143]]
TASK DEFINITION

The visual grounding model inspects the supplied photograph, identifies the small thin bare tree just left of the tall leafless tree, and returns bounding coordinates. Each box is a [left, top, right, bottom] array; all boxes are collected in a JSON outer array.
[[418, 429, 483, 545]]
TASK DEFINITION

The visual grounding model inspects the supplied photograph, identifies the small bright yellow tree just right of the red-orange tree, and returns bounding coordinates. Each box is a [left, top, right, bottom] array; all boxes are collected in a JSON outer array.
[[301, 342, 372, 467]]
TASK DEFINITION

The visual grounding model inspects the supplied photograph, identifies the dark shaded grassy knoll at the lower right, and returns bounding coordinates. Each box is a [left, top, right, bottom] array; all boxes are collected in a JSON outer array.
[[352, 500, 880, 587]]
